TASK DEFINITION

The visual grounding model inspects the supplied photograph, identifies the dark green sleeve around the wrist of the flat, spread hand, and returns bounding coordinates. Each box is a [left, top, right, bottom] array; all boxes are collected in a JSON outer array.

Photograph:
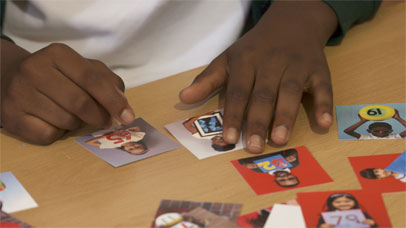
[[251, 0, 382, 45]]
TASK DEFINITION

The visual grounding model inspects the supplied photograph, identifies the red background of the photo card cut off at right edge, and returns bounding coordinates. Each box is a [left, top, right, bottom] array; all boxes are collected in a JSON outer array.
[[348, 153, 406, 193]]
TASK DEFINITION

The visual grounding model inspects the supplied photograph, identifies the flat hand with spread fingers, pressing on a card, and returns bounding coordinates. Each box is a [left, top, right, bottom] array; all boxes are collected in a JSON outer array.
[[180, 1, 337, 153]]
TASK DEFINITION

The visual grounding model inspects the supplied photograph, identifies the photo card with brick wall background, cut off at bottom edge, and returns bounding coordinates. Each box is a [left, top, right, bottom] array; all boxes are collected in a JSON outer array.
[[151, 200, 242, 228]]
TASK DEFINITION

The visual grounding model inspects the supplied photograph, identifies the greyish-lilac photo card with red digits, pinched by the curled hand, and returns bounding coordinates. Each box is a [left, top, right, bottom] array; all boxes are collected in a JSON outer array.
[[76, 118, 180, 167]]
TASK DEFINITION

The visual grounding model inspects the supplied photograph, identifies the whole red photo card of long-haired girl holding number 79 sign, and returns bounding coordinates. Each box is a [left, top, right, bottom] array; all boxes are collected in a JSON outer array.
[[297, 190, 391, 228]]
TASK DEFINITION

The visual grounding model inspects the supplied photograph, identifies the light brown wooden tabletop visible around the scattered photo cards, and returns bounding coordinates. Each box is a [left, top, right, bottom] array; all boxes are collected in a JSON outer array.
[[0, 2, 406, 227]]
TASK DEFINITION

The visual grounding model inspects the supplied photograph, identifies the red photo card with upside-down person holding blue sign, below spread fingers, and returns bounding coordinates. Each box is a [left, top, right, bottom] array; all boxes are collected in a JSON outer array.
[[231, 146, 332, 195]]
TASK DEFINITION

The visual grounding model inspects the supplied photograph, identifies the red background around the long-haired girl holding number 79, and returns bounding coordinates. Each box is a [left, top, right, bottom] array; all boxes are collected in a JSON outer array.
[[297, 190, 392, 227]]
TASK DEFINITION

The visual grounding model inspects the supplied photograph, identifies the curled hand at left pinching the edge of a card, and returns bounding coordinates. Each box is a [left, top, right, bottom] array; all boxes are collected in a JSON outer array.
[[1, 39, 134, 144]]
